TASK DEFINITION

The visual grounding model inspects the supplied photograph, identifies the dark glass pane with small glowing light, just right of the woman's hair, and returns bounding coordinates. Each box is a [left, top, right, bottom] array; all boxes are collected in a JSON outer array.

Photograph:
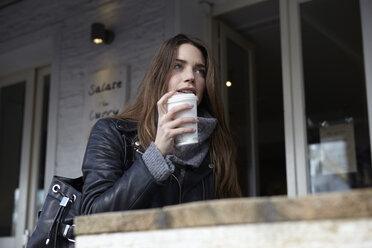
[[215, 21, 258, 196]]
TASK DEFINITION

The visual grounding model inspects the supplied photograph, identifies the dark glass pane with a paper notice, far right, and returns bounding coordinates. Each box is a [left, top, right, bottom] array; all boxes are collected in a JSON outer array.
[[299, 0, 372, 193]]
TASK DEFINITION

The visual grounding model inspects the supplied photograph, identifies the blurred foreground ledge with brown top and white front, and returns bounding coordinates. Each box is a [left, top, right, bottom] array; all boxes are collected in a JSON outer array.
[[75, 189, 372, 248]]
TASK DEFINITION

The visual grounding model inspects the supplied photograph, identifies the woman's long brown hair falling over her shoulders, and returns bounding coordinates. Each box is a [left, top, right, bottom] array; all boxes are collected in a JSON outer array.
[[118, 34, 241, 198]]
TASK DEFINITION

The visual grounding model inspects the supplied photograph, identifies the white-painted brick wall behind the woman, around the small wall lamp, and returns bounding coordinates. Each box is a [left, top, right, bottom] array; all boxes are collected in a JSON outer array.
[[51, 0, 165, 176]]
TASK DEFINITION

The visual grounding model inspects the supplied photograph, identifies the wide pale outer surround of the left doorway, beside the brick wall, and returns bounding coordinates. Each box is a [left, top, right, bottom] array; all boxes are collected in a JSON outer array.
[[0, 23, 62, 248]]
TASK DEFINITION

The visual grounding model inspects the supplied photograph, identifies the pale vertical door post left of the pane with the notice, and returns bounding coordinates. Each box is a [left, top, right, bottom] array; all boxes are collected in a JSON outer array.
[[279, 0, 309, 197]]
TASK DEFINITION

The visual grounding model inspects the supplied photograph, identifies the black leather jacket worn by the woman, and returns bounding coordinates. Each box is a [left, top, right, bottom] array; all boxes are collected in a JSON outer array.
[[81, 118, 214, 214]]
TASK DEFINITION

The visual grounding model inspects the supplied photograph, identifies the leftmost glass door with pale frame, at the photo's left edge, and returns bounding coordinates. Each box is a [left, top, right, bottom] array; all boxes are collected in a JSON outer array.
[[0, 71, 34, 247]]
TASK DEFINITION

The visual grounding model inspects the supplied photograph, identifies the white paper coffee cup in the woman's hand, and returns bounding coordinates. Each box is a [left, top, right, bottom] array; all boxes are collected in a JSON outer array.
[[167, 94, 198, 146]]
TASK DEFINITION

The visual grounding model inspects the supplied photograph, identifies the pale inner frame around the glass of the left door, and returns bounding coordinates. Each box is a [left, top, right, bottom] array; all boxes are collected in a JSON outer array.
[[0, 66, 51, 247]]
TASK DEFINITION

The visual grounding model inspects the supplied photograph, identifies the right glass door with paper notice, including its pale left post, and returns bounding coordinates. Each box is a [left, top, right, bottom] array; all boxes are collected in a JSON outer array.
[[280, 0, 372, 195]]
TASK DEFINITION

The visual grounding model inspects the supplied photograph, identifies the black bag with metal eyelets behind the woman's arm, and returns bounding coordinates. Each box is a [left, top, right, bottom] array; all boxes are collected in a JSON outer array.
[[27, 176, 83, 248]]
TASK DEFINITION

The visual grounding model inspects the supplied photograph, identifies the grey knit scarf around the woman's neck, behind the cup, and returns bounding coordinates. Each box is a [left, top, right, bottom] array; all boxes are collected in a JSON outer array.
[[165, 111, 217, 168]]
